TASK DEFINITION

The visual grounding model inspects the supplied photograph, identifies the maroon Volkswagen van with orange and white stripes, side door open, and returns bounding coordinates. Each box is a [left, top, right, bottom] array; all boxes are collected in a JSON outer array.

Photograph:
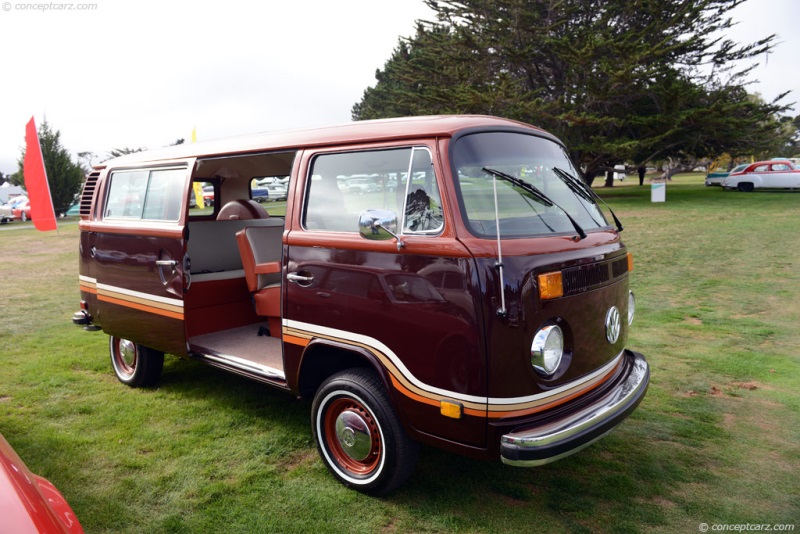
[[73, 116, 649, 494]]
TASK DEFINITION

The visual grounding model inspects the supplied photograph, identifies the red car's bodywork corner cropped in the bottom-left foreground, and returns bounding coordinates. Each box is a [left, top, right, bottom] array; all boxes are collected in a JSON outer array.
[[0, 435, 83, 534]]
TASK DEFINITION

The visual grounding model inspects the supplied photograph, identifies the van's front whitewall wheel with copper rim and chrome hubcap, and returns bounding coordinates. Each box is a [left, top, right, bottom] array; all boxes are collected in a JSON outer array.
[[311, 369, 419, 495]]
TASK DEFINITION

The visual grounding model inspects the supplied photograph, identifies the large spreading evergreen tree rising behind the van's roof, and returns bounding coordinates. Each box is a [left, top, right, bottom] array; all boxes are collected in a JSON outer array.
[[352, 0, 788, 182]]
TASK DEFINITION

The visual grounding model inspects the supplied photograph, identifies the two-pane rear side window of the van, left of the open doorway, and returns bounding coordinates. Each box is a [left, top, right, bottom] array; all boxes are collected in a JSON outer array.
[[103, 169, 186, 221]]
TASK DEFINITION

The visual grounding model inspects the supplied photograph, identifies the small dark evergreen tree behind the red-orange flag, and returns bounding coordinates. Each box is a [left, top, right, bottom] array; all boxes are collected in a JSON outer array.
[[11, 119, 86, 215]]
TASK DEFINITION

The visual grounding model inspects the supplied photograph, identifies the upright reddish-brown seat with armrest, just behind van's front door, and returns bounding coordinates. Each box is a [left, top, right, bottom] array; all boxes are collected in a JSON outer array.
[[236, 226, 283, 337]]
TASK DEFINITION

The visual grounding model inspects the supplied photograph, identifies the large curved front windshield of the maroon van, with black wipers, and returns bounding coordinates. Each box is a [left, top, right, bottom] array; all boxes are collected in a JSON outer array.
[[453, 132, 608, 238]]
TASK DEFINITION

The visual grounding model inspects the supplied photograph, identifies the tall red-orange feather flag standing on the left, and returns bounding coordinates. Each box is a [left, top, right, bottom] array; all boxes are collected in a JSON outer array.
[[22, 117, 58, 232]]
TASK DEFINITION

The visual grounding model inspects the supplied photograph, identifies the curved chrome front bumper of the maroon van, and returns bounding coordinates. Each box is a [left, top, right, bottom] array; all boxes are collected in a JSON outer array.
[[500, 350, 650, 467]]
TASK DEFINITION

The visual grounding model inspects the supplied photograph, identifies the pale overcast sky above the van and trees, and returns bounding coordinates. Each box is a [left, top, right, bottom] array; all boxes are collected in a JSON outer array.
[[0, 0, 800, 174]]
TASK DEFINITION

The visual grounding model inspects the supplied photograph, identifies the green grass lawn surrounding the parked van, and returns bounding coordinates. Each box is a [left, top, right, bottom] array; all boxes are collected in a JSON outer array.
[[0, 175, 800, 533]]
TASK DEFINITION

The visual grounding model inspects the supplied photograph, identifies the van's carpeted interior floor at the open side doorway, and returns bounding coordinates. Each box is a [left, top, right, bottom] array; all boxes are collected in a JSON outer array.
[[189, 322, 283, 372]]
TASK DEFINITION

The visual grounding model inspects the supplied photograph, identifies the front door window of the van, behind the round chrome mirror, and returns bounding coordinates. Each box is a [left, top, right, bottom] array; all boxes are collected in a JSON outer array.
[[303, 147, 443, 234]]
